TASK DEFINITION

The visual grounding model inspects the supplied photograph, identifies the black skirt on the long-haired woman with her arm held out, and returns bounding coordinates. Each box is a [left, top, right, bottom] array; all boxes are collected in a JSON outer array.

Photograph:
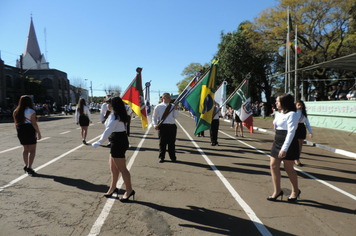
[[109, 131, 129, 158]]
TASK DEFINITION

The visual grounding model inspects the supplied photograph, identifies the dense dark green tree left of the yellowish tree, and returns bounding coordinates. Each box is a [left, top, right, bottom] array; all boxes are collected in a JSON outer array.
[[216, 22, 275, 101]]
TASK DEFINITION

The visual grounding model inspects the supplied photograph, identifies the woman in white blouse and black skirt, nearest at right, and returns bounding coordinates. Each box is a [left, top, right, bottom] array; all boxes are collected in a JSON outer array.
[[267, 93, 301, 202]]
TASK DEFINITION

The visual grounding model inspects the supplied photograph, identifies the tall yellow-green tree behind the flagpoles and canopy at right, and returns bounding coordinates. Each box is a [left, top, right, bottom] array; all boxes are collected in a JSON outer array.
[[244, 0, 356, 99]]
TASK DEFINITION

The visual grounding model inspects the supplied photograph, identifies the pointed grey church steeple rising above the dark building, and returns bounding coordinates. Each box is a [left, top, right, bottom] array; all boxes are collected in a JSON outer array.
[[16, 16, 49, 69]]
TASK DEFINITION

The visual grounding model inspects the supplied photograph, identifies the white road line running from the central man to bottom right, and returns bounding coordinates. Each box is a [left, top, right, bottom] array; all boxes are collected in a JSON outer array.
[[176, 121, 272, 236]]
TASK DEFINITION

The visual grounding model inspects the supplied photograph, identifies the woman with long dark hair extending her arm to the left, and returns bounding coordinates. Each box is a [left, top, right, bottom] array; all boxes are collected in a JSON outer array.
[[92, 97, 135, 202]]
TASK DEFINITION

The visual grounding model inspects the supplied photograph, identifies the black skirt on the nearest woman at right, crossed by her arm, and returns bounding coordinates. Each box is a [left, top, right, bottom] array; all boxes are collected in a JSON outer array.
[[271, 130, 299, 160]]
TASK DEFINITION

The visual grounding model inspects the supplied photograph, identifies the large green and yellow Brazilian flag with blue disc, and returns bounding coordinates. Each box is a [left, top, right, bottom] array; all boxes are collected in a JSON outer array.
[[186, 59, 219, 135]]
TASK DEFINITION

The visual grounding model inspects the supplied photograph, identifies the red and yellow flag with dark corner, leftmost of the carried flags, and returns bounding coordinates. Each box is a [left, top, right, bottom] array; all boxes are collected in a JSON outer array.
[[121, 68, 148, 130]]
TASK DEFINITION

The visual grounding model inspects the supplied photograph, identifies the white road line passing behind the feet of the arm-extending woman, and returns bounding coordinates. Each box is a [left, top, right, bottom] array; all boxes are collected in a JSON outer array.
[[88, 125, 151, 236]]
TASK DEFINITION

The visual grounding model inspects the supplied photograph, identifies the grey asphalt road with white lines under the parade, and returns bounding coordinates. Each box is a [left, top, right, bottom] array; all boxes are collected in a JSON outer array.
[[0, 112, 356, 236]]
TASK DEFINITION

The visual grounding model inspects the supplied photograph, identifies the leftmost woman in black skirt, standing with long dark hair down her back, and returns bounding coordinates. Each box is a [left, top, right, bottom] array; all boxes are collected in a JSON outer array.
[[13, 95, 41, 176]]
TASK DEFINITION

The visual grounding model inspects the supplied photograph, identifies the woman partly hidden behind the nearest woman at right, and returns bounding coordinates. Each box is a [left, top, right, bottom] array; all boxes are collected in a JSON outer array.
[[295, 100, 313, 167]]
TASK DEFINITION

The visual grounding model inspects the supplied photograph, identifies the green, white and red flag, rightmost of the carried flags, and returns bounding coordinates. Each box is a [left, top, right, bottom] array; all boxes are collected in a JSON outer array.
[[228, 76, 253, 134]]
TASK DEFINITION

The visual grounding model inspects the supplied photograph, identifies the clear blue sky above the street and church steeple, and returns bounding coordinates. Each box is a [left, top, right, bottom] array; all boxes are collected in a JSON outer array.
[[0, 0, 279, 104]]
